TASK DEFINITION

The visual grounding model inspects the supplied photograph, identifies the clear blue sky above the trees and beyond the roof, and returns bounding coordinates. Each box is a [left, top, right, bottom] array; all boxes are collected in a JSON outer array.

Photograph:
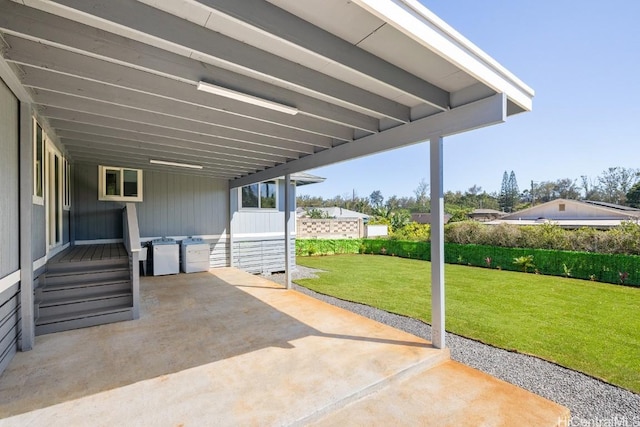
[[299, 0, 640, 198]]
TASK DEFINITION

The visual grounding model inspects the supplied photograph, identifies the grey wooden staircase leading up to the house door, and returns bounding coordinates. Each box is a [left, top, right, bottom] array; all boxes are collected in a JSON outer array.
[[34, 244, 134, 335]]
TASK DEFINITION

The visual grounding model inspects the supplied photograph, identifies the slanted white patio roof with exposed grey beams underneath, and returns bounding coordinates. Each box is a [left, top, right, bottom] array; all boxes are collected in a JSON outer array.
[[0, 0, 533, 187]]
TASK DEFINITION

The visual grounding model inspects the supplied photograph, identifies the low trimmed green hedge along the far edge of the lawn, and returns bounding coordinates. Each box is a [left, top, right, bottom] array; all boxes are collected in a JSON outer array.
[[296, 239, 640, 286]]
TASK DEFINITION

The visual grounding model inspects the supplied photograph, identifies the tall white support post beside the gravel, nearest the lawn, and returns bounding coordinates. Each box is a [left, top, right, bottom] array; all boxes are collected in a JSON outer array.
[[430, 137, 445, 348]]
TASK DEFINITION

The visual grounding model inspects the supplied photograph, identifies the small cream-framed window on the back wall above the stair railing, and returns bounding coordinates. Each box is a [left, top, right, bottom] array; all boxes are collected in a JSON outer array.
[[98, 166, 142, 202]]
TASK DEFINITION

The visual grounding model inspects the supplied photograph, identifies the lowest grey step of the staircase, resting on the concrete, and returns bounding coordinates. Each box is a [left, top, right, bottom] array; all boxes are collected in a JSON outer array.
[[36, 306, 133, 335]]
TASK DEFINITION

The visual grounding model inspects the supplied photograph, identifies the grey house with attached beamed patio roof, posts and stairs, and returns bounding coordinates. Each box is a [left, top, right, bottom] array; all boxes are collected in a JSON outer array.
[[0, 0, 533, 372]]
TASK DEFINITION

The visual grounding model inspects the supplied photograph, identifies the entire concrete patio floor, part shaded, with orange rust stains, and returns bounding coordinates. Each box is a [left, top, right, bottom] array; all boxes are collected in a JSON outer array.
[[0, 268, 568, 426]]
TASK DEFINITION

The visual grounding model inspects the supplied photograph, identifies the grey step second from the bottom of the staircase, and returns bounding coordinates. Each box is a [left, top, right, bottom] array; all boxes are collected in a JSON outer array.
[[38, 291, 133, 318]]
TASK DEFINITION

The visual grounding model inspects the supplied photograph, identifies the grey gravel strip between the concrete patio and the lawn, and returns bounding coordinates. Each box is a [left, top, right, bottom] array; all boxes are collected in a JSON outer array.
[[268, 266, 640, 427]]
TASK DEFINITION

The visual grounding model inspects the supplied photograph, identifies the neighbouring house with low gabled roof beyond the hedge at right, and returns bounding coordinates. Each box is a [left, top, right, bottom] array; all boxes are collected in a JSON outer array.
[[487, 199, 640, 228]]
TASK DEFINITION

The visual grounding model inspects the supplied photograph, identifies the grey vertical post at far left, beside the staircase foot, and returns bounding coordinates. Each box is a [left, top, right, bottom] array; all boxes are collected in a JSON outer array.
[[19, 102, 35, 351]]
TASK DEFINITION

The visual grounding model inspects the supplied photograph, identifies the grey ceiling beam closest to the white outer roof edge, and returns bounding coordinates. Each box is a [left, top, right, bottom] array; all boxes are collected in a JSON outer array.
[[197, 0, 449, 111]]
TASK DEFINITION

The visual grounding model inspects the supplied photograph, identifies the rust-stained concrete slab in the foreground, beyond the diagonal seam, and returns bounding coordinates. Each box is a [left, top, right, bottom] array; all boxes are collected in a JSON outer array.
[[313, 361, 570, 427]]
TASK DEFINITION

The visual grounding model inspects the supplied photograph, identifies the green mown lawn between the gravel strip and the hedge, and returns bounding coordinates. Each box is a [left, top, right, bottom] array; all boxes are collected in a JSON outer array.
[[297, 255, 640, 393]]
